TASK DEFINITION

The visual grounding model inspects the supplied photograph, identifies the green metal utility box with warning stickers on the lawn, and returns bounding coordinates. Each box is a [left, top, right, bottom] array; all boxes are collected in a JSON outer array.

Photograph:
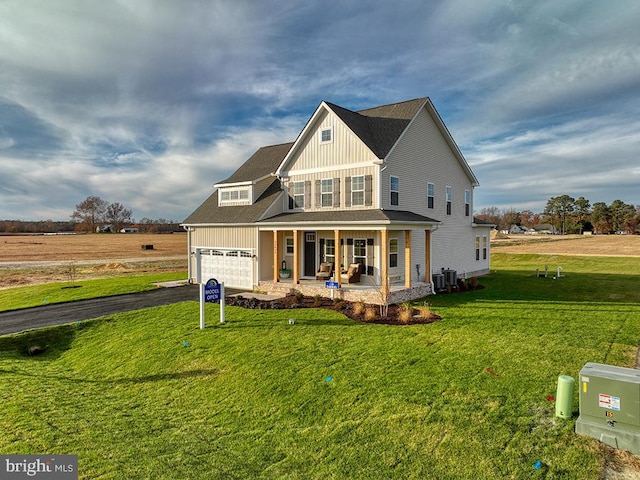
[[576, 363, 640, 455]]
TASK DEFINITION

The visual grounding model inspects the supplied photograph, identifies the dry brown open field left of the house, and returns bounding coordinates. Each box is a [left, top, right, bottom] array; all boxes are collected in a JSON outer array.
[[0, 233, 187, 289]]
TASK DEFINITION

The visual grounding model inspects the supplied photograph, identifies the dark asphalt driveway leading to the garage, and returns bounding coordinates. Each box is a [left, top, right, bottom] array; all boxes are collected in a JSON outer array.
[[0, 285, 240, 335]]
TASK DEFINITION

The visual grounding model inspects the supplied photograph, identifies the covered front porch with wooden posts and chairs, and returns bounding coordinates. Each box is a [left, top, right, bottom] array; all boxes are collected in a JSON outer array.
[[257, 223, 433, 304]]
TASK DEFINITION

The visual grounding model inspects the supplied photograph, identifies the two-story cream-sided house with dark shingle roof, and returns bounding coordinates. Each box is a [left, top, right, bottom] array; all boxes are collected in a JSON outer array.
[[183, 98, 491, 302]]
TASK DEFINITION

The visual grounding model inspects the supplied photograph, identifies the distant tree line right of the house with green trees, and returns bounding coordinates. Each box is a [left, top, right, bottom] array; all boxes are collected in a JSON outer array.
[[476, 195, 640, 234]]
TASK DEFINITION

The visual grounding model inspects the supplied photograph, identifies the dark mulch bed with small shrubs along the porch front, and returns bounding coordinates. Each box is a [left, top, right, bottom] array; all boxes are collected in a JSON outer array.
[[225, 295, 442, 325]]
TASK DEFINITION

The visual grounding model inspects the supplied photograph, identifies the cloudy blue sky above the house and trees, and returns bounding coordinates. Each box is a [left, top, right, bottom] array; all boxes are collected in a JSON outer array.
[[0, 0, 640, 221]]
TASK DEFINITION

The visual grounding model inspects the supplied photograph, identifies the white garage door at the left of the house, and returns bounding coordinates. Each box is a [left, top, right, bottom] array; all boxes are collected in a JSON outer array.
[[197, 248, 253, 290]]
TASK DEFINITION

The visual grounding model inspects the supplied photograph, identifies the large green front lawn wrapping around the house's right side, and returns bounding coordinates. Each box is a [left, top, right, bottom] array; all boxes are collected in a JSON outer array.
[[0, 254, 640, 479]]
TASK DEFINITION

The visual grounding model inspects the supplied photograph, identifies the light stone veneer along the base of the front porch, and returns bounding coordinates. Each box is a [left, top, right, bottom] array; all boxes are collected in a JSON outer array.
[[258, 282, 433, 305]]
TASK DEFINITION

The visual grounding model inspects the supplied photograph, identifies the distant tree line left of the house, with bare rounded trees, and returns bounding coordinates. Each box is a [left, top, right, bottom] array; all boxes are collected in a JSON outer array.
[[0, 196, 182, 233]]
